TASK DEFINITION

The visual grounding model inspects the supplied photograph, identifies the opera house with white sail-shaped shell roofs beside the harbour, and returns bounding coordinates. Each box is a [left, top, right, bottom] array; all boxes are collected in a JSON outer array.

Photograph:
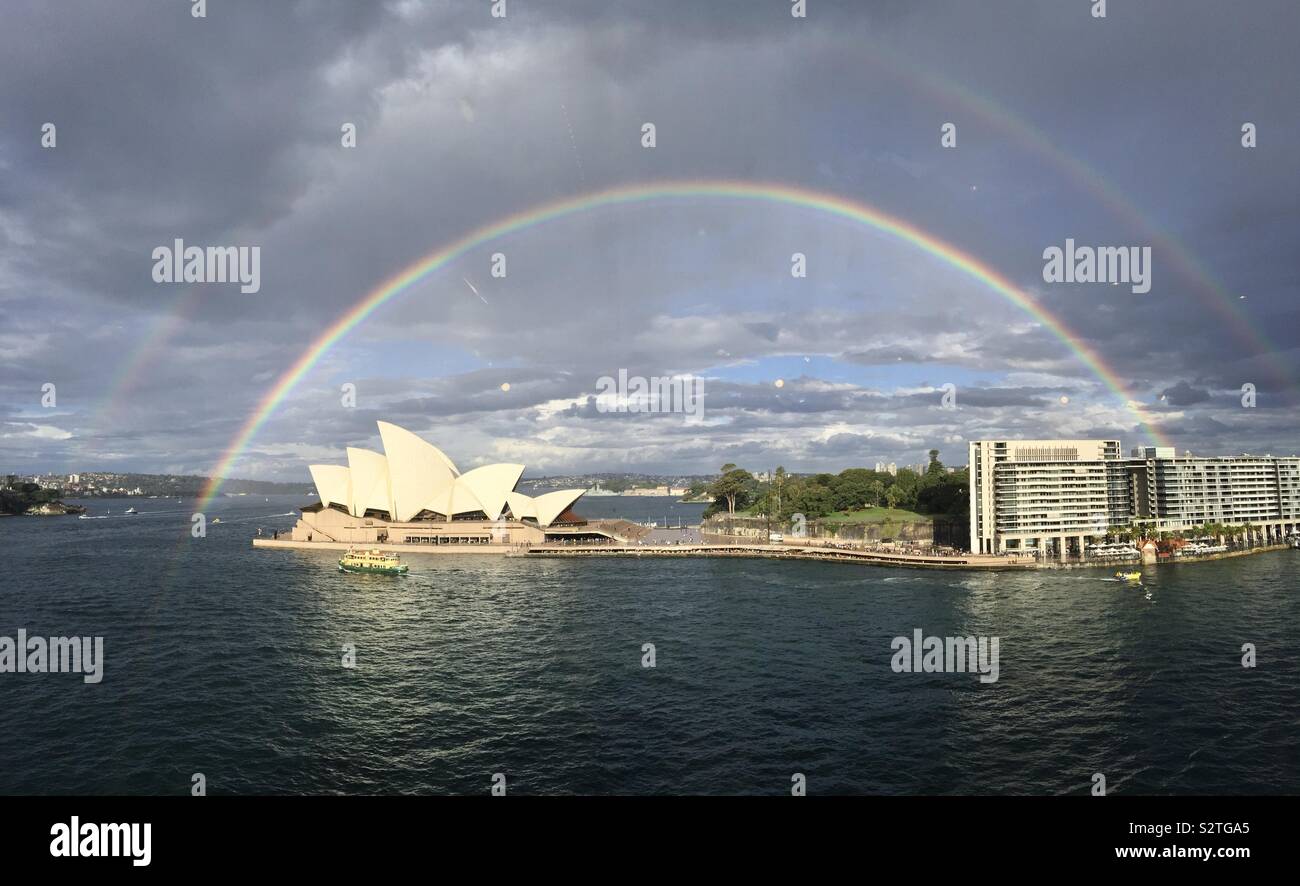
[[284, 421, 610, 550]]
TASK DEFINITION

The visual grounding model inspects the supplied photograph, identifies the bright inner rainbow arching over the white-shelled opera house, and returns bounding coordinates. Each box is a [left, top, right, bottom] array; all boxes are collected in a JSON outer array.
[[200, 181, 1167, 507]]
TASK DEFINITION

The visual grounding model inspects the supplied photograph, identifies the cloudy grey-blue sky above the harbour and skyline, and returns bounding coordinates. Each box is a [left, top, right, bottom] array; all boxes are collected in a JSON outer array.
[[0, 0, 1300, 481]]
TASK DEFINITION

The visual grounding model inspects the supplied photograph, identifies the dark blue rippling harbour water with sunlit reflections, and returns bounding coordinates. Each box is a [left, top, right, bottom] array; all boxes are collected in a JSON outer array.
[[0, 498, 1300, 794]]
